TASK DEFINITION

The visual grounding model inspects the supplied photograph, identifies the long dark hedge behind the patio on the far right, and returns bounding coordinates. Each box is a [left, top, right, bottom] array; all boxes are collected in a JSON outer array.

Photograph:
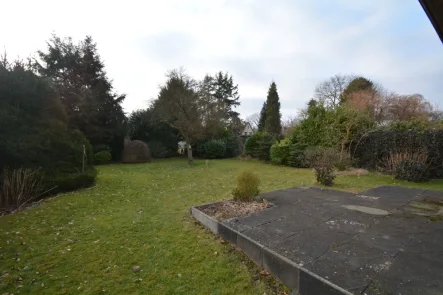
[[351, 130, 443, 178]]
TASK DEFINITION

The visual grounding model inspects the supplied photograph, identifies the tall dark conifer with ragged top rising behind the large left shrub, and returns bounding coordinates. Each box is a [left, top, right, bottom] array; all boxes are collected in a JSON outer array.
[[33, 35, 126, 159]]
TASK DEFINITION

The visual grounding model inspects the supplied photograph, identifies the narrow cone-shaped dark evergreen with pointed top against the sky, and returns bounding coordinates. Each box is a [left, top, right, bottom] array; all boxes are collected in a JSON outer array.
[[265, 82, 281, 135]]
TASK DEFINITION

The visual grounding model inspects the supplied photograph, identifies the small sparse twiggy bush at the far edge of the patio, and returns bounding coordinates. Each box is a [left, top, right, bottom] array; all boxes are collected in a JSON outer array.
[[305, 147, 339, 186]]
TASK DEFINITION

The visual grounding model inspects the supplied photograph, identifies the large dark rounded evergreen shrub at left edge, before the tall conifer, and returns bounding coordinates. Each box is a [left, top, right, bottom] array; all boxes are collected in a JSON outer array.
[[0, 64, 93, 194]]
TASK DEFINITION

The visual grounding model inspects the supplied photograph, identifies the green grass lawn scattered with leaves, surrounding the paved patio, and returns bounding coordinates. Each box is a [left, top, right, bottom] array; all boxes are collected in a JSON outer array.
[[0, 159, 443, 294]]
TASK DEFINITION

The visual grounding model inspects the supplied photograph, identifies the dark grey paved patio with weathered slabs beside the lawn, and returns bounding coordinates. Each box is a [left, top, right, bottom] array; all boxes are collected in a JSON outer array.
[[223, 186, 443, 295]]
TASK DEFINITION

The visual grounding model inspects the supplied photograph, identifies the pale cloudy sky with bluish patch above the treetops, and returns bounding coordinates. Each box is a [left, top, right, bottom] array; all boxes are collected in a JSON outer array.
[[0, 0, 443, 118]]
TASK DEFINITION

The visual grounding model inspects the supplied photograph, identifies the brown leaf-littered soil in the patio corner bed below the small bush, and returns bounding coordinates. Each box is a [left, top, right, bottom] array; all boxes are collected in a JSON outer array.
[[199, 200, 271, 220]]
